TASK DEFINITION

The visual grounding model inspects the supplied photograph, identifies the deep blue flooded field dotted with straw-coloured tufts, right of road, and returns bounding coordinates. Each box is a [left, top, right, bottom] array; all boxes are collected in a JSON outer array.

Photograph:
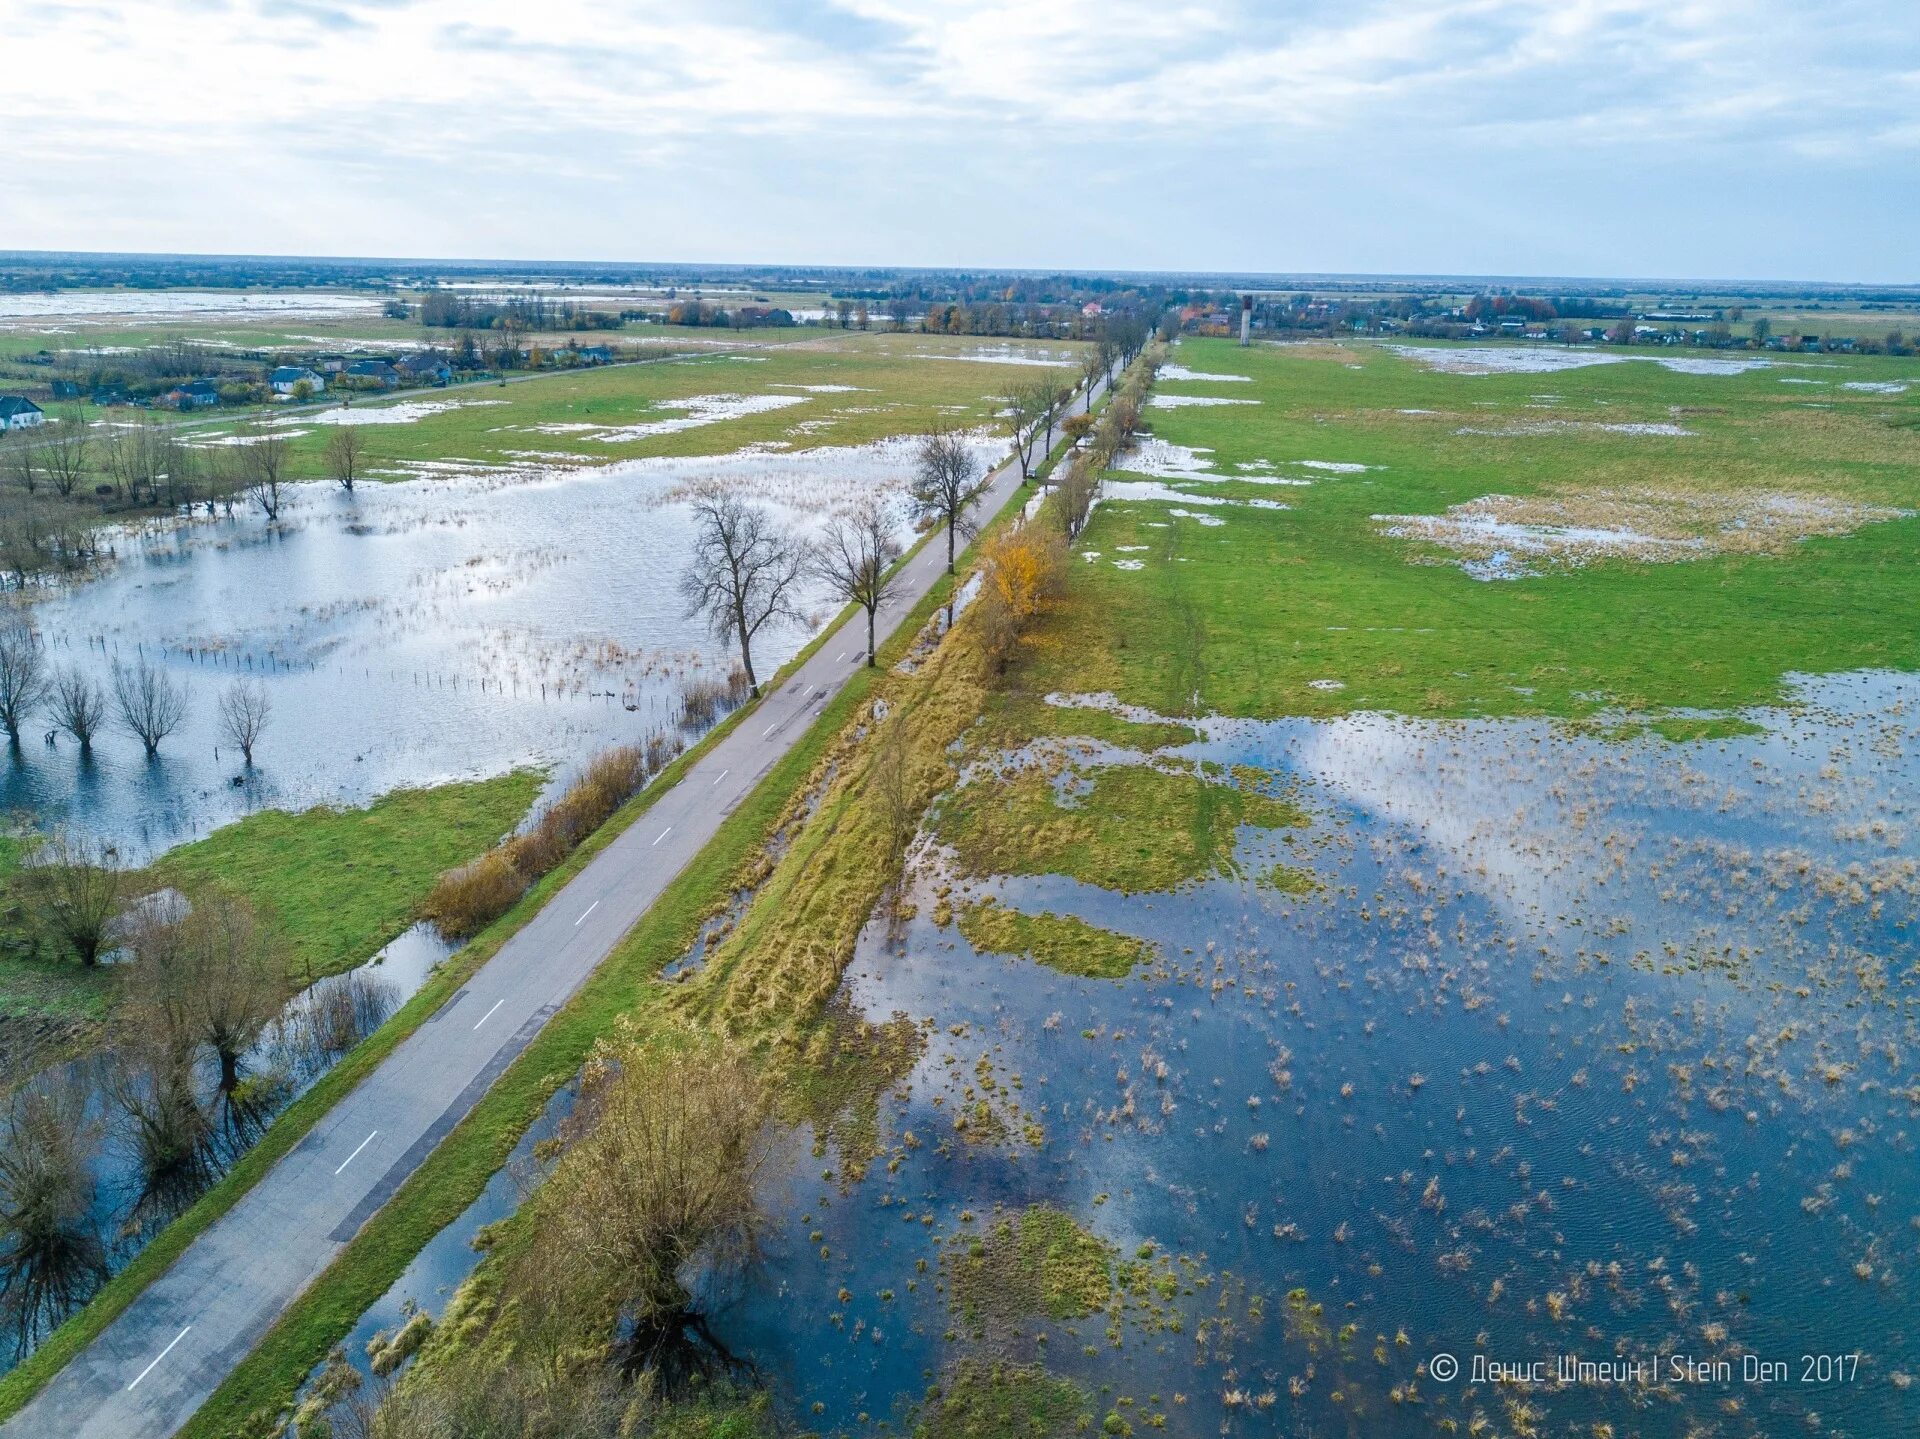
[[716, 674, 1920, 1439]]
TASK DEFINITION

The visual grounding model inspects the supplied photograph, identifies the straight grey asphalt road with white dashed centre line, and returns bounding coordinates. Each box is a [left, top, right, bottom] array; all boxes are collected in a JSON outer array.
[[0, 365, 1113, 1439]]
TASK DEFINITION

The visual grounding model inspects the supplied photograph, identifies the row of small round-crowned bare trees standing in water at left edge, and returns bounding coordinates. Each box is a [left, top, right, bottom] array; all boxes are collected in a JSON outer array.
[[0, 624, 273, 767]]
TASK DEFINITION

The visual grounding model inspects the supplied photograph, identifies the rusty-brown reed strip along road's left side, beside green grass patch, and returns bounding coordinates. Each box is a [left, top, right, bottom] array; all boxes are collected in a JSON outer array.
[[420, 734, 660, 939]]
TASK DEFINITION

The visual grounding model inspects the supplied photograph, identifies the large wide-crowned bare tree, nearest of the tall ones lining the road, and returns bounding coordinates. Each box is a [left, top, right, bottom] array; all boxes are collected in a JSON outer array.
[[680, 488, 806, 695]]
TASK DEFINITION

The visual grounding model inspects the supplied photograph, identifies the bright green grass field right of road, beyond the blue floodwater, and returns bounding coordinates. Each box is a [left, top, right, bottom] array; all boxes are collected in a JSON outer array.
[[1031, 340, 1920, 715]]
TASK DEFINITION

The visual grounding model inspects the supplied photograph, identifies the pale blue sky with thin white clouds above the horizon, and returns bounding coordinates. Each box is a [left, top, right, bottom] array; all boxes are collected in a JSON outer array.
[[0, 0, 1920, 280]]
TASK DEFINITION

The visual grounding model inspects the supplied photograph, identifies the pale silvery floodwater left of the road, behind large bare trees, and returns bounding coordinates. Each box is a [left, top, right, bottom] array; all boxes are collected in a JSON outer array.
[[15, 440, 989, 855]]
